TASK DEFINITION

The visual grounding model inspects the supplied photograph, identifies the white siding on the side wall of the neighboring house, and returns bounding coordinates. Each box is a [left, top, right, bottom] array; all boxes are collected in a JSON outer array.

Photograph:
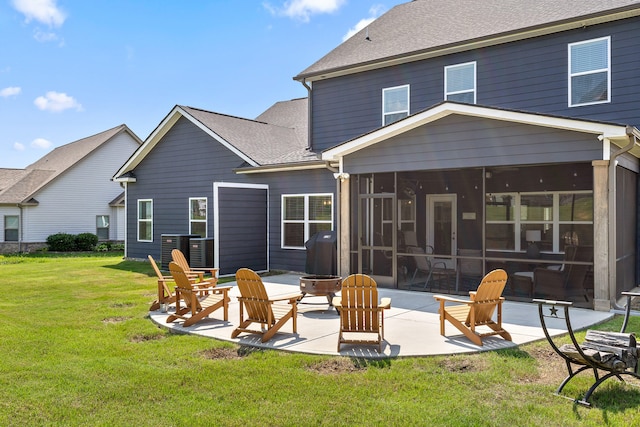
[[23, 132, 138, 242]]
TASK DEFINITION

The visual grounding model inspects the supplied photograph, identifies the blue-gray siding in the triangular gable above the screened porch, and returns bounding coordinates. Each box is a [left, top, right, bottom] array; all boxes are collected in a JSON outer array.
[[345, 116, 602, 173]]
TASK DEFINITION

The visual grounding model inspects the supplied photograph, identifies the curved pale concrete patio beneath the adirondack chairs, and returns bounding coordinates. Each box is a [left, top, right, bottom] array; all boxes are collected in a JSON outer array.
[[149, 274, 613, 358]]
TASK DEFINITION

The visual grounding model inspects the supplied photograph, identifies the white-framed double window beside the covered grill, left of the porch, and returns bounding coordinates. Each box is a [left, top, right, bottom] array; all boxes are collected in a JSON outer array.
[[282, 194, 333, 249]]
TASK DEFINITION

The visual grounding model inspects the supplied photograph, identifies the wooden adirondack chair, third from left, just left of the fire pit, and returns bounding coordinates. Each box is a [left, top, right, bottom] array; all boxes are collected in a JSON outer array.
[[231, 268, 302, 342]]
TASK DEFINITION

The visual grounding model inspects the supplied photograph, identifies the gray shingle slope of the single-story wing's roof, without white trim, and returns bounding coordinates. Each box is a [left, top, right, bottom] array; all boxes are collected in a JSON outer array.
[[180, 98, 318, 166]]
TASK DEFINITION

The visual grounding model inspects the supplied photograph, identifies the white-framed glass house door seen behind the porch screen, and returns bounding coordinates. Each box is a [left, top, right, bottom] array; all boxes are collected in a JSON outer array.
[[427, 194, 458, 268]]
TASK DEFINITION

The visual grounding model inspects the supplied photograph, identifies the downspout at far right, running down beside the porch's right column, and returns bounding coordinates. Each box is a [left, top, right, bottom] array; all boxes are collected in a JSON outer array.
[[608, 126, 638, 310]]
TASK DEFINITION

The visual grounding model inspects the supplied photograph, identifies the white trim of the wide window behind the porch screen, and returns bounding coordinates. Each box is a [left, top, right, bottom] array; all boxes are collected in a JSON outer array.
[[486, 190, 593, 253]]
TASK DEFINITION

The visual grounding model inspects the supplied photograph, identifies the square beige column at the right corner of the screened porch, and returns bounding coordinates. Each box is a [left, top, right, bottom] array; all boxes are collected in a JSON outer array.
[[591, 160, 615, 311]]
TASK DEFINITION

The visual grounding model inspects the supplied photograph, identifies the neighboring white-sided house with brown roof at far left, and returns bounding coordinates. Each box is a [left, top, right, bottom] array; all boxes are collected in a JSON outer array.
[[0, 125, 142, 253]]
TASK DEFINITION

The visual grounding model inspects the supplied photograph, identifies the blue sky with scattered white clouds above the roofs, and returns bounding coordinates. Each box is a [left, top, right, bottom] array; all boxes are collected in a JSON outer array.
[[0, 0, 407, 168]]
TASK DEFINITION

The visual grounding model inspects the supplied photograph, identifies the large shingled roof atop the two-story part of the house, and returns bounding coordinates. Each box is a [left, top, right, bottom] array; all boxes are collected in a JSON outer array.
[[294, 0, 640, 81]]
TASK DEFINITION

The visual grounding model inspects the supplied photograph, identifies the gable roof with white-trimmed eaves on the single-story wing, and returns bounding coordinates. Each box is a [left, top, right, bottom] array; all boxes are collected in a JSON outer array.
[[114, 98, 319, 181]]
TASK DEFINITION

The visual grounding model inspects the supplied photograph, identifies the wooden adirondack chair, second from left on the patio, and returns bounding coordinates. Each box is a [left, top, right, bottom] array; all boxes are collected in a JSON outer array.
[[167, 261, 231, 327]]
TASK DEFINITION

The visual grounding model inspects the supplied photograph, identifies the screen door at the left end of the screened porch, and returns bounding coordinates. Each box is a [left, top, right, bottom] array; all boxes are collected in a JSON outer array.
[[358, 194, 396, 287]]
